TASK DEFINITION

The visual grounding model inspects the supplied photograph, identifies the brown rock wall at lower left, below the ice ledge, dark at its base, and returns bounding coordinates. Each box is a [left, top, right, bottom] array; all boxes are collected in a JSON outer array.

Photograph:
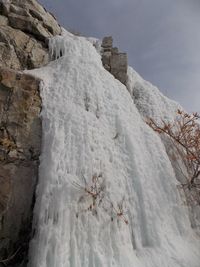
[[0, 68, 41, 266]]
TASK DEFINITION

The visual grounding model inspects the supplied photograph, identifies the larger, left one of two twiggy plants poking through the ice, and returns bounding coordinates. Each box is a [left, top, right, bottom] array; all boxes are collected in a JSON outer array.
[[73, 173, 105, 217]]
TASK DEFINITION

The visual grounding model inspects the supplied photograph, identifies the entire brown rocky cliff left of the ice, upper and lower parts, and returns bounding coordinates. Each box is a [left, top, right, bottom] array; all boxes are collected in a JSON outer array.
[[0, 0, 61, 266]]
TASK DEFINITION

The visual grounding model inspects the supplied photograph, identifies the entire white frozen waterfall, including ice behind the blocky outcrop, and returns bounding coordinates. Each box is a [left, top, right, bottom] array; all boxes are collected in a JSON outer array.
[[29, 33, 200, 267]]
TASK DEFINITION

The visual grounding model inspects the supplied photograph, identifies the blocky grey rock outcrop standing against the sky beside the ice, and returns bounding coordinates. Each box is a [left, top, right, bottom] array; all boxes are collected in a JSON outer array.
[[101, 36, 128, 85]]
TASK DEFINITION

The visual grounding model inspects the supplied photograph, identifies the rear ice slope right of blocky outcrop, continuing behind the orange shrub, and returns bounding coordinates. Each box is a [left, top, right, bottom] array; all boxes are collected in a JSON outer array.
[[127, 67, 200, 234]]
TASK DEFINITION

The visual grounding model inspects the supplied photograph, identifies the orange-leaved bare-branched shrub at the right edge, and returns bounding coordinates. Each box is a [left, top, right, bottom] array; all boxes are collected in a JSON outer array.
[[147, 110, 200, 204]]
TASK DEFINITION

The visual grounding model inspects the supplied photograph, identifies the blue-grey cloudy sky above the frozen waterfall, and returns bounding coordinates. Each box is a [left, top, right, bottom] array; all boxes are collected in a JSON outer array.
[[39, 0, 200, 112]]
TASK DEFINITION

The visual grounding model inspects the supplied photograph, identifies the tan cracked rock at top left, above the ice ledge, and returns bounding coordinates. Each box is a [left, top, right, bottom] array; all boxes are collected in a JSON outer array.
[[0, 0, 61, 70]]
